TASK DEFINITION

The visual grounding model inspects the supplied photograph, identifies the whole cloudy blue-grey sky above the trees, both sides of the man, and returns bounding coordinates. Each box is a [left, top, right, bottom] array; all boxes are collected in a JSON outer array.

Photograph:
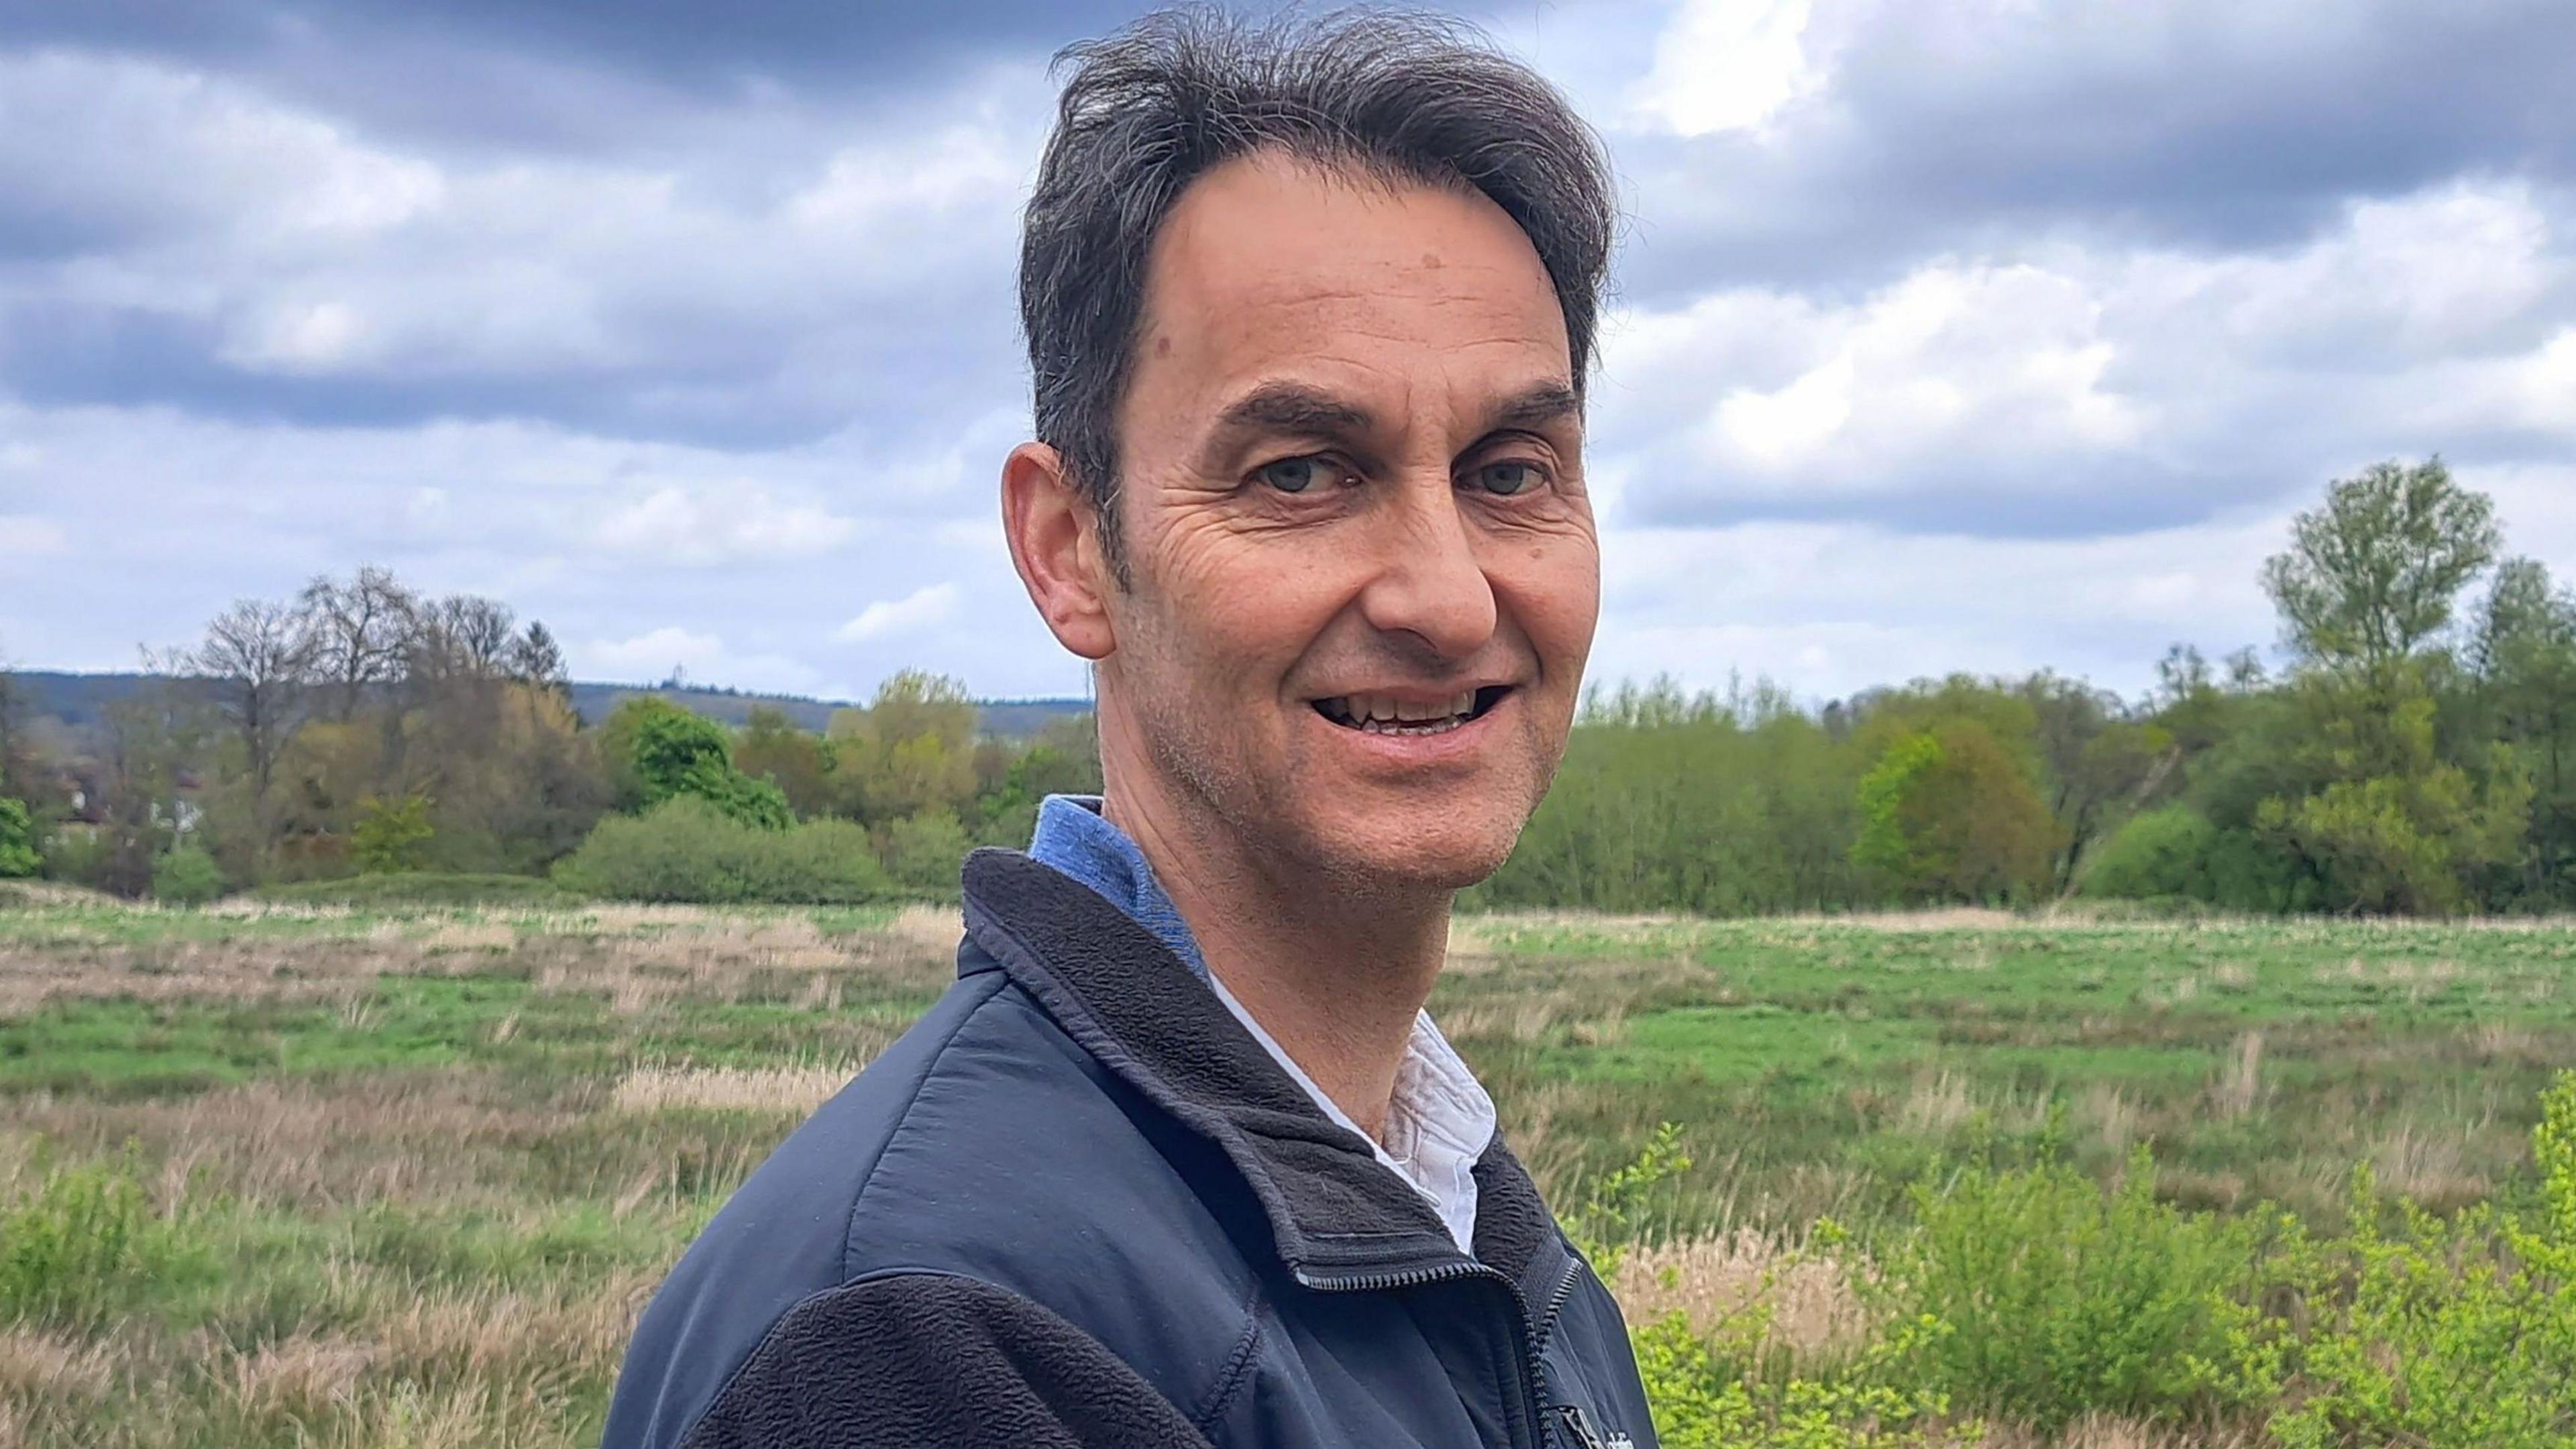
[[0, 0, 2576, 699]]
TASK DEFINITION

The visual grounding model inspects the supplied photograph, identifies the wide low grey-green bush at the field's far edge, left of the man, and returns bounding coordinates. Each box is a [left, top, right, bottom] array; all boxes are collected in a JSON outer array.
[[554, 794, 896, 905]]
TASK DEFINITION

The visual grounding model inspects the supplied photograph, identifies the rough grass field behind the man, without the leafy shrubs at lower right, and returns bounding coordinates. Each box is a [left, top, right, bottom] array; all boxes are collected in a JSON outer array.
[[0, 900, 2576, 1449]]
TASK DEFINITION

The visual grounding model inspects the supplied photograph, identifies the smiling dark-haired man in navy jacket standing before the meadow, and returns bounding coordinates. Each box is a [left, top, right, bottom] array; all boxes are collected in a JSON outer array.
[[608, 13, 1654, 1449]]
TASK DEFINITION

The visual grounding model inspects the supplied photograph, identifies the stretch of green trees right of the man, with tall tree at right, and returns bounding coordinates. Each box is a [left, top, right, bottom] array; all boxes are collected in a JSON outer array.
[[1476, 462, 2576, 915]]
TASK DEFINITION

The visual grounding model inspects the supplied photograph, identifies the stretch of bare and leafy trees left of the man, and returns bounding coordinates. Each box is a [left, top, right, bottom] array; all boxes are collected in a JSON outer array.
[[0, 568, 1100, 900]]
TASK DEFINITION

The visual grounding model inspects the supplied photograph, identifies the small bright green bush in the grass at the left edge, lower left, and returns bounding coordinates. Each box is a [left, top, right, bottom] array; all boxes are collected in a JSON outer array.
[[0, 1165, 185, 1333]]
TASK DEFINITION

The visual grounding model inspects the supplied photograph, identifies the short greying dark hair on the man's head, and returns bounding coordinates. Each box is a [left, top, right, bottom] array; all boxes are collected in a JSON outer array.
[[1020, 8, 1618, 580]]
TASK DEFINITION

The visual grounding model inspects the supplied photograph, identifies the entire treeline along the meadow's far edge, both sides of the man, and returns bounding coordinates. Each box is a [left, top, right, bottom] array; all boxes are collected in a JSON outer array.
[[0, 462, 2576, 915]]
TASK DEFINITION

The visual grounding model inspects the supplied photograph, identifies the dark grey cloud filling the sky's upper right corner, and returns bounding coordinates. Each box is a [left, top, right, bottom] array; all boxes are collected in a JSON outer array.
[[1620, 0, 2576, 299]]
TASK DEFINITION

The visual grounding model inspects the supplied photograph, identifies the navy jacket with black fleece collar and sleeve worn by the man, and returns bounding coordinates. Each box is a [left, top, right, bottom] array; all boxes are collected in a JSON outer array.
[[608, 851, 1654, 1449]]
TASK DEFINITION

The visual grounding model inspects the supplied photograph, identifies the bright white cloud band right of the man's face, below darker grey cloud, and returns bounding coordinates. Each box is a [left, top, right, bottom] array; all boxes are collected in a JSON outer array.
[[1595, 170, 2576, 534]]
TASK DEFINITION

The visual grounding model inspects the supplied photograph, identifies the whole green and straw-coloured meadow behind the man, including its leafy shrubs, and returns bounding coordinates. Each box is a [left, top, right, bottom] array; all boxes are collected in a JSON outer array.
[[0, 887, 2576, 1449]]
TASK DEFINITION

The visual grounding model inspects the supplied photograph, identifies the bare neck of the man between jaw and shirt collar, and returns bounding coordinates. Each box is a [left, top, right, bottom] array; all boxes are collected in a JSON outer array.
[[1103, 779, 1450, 1140]]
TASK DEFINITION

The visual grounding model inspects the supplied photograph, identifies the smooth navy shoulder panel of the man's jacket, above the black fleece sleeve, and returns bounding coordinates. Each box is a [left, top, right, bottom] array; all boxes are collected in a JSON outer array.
[[595, 938, 1252, 1444]]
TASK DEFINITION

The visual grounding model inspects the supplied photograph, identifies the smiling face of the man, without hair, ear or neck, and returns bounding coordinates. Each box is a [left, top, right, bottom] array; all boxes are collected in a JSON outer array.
[[1103, 155, 1600, 887]]
